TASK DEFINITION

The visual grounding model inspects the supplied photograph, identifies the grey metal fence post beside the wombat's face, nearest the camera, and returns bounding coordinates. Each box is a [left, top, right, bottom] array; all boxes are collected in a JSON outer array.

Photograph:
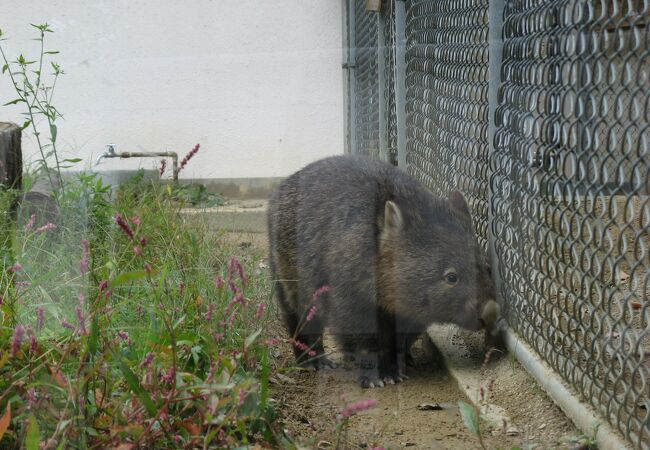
[[488, 0, 505, 295]]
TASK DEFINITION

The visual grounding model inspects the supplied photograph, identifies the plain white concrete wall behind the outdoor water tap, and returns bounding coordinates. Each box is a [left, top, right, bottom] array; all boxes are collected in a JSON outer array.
[[0, 0, 344, 178]]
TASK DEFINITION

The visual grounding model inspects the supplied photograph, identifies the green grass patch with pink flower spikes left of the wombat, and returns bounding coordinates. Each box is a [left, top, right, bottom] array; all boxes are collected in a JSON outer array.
[[0, 171, 284, 449]]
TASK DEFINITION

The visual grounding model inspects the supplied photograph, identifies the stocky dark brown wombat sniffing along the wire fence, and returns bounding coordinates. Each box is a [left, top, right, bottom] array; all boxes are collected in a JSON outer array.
[[268, 156, 498, 387]]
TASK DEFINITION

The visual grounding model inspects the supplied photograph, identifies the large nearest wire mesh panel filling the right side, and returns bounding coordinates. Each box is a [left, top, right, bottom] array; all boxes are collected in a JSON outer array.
[[490, 0, 650, 448]]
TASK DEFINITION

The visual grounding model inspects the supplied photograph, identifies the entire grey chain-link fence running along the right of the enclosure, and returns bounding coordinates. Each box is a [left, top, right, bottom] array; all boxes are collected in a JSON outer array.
[[352, 0, 650, 449]]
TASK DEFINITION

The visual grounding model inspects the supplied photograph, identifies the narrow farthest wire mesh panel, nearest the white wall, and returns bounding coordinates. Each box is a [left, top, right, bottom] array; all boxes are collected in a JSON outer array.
[[352, 0, 380, 158]]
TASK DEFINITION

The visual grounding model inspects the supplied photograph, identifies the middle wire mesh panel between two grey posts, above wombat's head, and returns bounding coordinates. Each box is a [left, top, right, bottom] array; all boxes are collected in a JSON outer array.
[[406, 0, 489, 248]]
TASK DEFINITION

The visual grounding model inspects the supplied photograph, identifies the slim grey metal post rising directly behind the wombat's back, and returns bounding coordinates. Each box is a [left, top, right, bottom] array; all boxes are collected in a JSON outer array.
[[395, 0, 406, 170]]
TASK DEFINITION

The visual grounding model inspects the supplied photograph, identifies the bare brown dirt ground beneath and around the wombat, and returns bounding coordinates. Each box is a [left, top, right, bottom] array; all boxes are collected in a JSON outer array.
[[206, 225, 581, 449]]
